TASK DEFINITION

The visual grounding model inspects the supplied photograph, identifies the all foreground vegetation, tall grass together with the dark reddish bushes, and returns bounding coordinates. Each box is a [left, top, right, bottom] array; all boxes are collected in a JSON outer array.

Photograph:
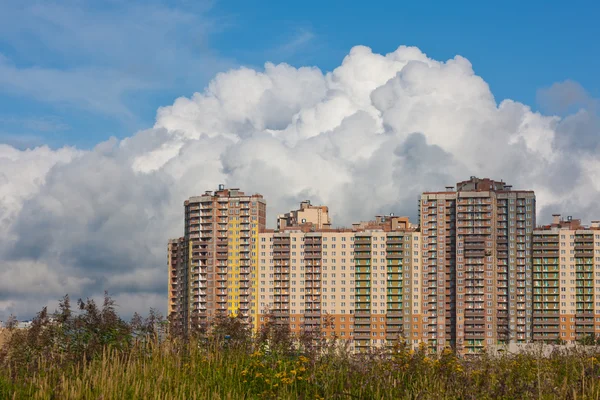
[[0, 296, 600, 400]]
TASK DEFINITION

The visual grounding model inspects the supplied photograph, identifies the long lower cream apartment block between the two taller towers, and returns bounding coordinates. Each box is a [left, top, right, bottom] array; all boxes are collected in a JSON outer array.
[[257, 211, 421, 350]]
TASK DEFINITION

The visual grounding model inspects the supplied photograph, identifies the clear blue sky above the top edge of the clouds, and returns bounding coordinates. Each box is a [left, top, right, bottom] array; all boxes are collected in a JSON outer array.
[[0, 0, 600, 148]]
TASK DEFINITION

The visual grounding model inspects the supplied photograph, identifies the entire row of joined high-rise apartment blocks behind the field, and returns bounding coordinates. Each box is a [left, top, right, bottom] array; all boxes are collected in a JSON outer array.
[[168, 177, 600, 353]]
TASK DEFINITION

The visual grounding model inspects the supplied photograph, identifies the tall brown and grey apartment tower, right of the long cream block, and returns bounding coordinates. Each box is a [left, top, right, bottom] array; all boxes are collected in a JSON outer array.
[[419, 177, 536, 352]]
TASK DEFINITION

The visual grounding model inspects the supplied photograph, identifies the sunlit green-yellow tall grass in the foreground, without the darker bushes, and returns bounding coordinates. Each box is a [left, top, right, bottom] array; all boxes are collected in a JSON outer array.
[[0, 341, 600, 399]]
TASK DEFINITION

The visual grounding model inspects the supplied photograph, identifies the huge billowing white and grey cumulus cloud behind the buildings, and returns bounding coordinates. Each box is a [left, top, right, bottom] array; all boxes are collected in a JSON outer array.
[[0, 46, 600, 319]]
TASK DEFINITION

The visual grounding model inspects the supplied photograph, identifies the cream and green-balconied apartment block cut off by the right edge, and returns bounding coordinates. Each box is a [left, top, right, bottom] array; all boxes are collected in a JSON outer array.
[[533, 214, 600, 342]]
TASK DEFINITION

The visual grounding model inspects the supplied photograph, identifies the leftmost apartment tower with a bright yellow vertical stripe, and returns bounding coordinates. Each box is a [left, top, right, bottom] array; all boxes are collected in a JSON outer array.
[[169, 185, 266, 329]]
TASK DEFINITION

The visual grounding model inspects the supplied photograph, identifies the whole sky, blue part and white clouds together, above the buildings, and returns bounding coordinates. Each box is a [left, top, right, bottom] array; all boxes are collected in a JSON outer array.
[[0, 0, 600, 319]]
